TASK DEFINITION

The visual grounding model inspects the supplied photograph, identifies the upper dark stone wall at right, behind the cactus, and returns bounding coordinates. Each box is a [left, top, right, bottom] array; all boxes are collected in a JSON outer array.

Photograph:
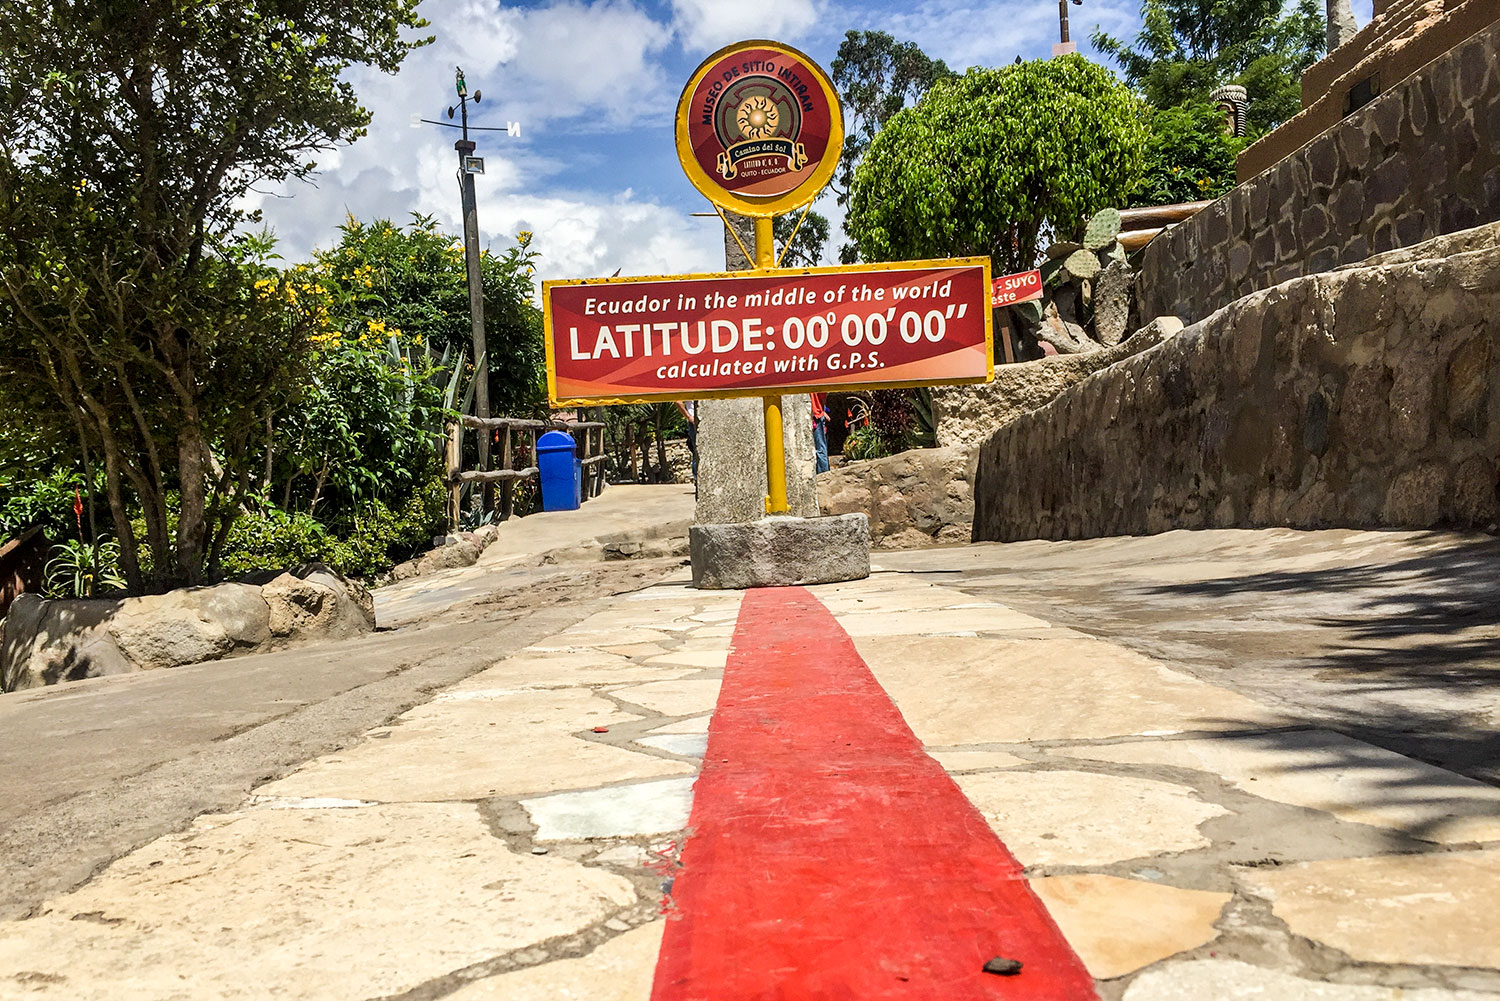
[[1140, 24, 1500, 323]]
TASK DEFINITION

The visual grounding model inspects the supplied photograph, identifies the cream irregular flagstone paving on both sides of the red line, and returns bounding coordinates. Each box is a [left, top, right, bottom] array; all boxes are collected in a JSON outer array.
[[0, 551, 1500, 1001]]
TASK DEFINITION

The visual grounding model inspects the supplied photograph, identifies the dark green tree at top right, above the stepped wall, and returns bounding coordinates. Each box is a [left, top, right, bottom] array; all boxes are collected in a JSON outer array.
[[1091, 0, 1325, 137]]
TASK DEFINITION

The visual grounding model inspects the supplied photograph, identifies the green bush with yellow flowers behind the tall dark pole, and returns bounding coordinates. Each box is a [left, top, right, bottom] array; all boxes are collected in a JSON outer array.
[[242, 216, 545, 555]]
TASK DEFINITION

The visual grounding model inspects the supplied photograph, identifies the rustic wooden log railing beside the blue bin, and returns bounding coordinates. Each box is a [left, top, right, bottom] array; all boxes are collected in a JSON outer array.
[[444, 416, 605, 528]]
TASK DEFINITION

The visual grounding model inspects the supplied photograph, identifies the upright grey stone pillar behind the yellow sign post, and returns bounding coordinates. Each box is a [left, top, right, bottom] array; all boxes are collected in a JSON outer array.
[[695, 215, 818, 525]]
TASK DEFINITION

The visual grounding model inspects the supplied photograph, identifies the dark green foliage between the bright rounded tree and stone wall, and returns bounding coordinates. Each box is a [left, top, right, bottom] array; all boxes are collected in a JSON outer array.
[[1130, 102, 1250, 206]]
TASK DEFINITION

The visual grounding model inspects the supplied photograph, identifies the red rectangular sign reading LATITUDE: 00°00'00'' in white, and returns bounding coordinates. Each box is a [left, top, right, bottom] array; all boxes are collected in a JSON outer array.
[[542, 258, 995, 407]]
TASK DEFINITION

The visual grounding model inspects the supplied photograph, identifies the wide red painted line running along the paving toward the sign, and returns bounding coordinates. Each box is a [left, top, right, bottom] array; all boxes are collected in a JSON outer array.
[[651, 588, 1097, 1001]]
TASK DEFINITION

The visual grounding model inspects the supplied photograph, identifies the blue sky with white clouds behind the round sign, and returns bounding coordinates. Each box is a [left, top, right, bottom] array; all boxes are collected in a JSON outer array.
[[249, 0, 1371, 279]]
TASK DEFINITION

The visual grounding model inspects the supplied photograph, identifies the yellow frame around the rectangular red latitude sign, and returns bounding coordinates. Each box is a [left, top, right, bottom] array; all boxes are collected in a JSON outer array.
[[542, 257, 995, 407]]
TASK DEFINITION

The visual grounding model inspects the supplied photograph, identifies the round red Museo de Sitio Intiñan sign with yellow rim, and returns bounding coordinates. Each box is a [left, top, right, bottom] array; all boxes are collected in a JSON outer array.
[[677, 41, 843, 216]]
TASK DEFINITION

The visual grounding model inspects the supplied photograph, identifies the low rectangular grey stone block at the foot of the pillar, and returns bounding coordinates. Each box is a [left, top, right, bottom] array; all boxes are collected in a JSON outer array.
[[689, 513, 870, 590]]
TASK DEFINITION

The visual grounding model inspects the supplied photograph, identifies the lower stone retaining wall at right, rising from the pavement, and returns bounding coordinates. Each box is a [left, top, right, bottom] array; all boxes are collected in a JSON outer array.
[[975, 235, 1500, 540]]
